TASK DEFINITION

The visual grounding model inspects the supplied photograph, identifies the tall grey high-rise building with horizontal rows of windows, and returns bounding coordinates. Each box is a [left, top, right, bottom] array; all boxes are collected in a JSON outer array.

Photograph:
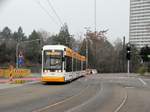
[[129, 0, 150, 49]]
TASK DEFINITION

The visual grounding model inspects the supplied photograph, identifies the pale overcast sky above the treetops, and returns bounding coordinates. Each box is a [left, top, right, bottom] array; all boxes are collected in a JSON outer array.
[[0, 0, 129, 42]]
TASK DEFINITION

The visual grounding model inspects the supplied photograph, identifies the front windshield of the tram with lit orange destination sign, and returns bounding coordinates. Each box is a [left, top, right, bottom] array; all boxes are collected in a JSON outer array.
[[43, 51, 63, 70]]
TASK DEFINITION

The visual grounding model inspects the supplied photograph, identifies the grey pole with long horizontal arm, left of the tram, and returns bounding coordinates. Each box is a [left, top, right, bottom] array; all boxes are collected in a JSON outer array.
[[16, 39, 41, 69]]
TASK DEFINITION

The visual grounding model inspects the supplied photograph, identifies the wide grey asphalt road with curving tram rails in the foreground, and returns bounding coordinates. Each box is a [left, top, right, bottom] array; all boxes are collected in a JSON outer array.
[[0, 74, 150, 112]]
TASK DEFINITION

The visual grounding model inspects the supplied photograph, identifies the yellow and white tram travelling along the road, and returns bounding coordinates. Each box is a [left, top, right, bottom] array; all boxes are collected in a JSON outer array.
[[41, 45, 86, 82]]
